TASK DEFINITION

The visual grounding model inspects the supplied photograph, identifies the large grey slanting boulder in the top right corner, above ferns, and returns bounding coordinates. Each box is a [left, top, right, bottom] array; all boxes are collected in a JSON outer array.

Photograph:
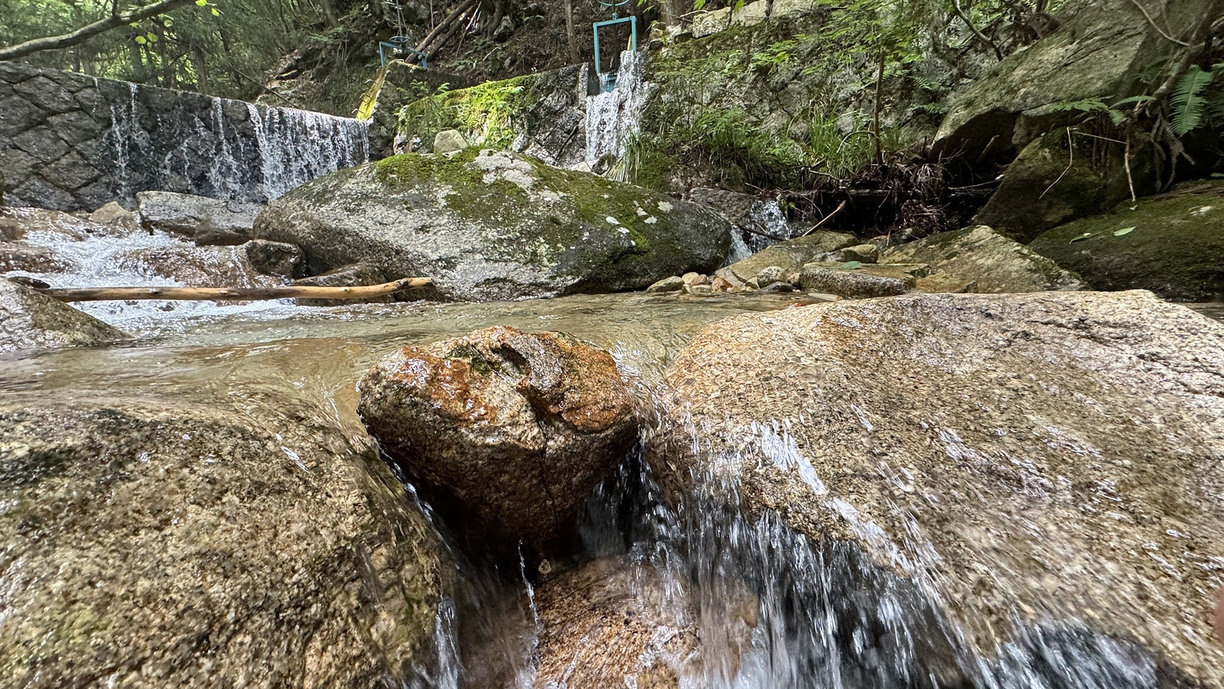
[[933, 0, 1219, 159]]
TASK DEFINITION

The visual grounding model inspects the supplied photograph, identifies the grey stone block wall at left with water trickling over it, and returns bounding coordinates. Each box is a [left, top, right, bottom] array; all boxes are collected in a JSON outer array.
[[0, 62, 370, 210]]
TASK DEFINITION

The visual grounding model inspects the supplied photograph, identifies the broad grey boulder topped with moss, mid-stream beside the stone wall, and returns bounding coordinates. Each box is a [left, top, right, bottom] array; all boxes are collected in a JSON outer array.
[[255, 148, 731, 301]]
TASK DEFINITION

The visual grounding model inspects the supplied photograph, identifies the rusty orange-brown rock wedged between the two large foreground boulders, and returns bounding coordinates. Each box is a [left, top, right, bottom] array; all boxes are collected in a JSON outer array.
[[357, 327, 638, 552]]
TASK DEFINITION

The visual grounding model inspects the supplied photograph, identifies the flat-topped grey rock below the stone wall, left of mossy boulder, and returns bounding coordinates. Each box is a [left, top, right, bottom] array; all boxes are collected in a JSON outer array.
[[136, 191, 261, 244]]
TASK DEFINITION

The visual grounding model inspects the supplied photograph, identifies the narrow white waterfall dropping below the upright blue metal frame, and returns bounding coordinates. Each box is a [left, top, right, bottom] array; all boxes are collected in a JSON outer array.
[[585, 50, 652, 169]]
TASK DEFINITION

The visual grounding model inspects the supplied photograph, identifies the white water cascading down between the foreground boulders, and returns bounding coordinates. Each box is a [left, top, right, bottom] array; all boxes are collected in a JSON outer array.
[[428, 381, 1173, 689]]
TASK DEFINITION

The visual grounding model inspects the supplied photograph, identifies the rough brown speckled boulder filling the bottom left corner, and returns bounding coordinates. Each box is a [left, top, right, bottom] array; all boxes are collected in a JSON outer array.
[[0, 399, 454, 688]]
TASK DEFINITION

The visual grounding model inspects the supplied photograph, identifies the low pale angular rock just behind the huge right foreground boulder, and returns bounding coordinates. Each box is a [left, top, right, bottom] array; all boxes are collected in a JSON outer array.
[[880, 225, 1084, 294]]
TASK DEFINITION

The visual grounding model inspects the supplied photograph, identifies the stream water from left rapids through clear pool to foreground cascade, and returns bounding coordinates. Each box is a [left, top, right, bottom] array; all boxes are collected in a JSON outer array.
[[0, 217, 1224, 689]]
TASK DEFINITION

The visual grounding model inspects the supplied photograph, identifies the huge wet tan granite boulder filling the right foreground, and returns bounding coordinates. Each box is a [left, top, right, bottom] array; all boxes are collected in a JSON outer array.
[[649, 291, 1224, 688]]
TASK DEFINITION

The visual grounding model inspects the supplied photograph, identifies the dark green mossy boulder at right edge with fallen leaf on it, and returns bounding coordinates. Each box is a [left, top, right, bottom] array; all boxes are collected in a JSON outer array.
[[1028, 181, 1224, 301]]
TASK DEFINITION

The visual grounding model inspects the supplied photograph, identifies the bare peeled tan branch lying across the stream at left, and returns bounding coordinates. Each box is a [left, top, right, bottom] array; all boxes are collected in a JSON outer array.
[[37, 278, 433, 301]]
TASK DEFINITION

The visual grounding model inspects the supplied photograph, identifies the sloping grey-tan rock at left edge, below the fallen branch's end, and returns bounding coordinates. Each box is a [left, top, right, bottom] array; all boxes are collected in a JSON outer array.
[[0, 278, 129, 351]]
